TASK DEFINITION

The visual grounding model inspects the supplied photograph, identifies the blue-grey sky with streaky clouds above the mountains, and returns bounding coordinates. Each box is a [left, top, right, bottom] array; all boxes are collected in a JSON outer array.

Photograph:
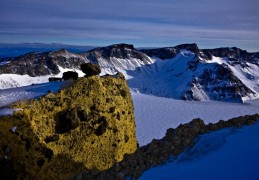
[[0, 0, 259, 51]]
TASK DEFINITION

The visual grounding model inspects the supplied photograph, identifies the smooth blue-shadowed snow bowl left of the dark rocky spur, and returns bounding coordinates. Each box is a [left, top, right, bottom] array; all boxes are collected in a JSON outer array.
[[126, 50, 200, 99]]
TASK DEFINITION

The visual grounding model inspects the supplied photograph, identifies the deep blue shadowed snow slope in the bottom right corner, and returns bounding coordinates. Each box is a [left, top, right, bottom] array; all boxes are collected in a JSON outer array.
[[139, 122, 259, 180]]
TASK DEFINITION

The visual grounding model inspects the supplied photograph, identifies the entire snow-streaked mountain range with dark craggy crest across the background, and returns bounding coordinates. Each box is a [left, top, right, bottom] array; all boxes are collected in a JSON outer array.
[[0, 44, 259, 102]]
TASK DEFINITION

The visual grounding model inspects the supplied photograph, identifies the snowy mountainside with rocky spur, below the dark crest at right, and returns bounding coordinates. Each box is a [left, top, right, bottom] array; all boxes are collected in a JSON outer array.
[[126, 50, 259, 102]]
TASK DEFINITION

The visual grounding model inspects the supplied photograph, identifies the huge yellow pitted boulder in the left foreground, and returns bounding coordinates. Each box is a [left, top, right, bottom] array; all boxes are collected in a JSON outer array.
[[0, 75, 137, 179]]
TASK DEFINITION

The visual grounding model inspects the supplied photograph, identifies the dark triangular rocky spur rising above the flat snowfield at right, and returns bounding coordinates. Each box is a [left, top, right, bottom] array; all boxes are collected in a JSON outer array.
[[182, 64, 256, 102]]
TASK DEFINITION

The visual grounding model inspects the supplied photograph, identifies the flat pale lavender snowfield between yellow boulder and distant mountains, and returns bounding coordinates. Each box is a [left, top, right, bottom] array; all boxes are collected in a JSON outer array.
[[131, 91, 259, 146]]
